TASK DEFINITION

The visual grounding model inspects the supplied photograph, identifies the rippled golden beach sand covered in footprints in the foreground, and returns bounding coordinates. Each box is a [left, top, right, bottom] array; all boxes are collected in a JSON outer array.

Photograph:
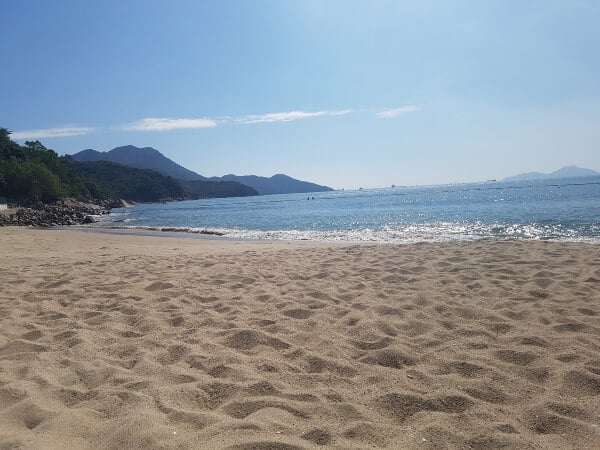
[[0, 228, 600, 450]]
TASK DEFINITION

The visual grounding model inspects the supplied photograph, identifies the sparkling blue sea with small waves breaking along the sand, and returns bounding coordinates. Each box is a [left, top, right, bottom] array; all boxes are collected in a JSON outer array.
[[95, 177, 600, 243]]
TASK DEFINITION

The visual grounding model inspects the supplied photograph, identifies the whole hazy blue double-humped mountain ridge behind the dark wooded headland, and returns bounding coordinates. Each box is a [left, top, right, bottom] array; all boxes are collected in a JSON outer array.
[[71, 145, 333, 195]]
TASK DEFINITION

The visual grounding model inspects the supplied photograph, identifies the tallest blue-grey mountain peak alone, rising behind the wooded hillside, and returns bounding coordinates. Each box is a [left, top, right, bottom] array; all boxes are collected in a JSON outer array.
[[71, 145, 206, 181]]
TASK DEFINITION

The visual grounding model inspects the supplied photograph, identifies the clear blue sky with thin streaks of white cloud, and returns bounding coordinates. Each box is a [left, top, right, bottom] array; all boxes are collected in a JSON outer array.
[[0, 0, 600, 189]]
